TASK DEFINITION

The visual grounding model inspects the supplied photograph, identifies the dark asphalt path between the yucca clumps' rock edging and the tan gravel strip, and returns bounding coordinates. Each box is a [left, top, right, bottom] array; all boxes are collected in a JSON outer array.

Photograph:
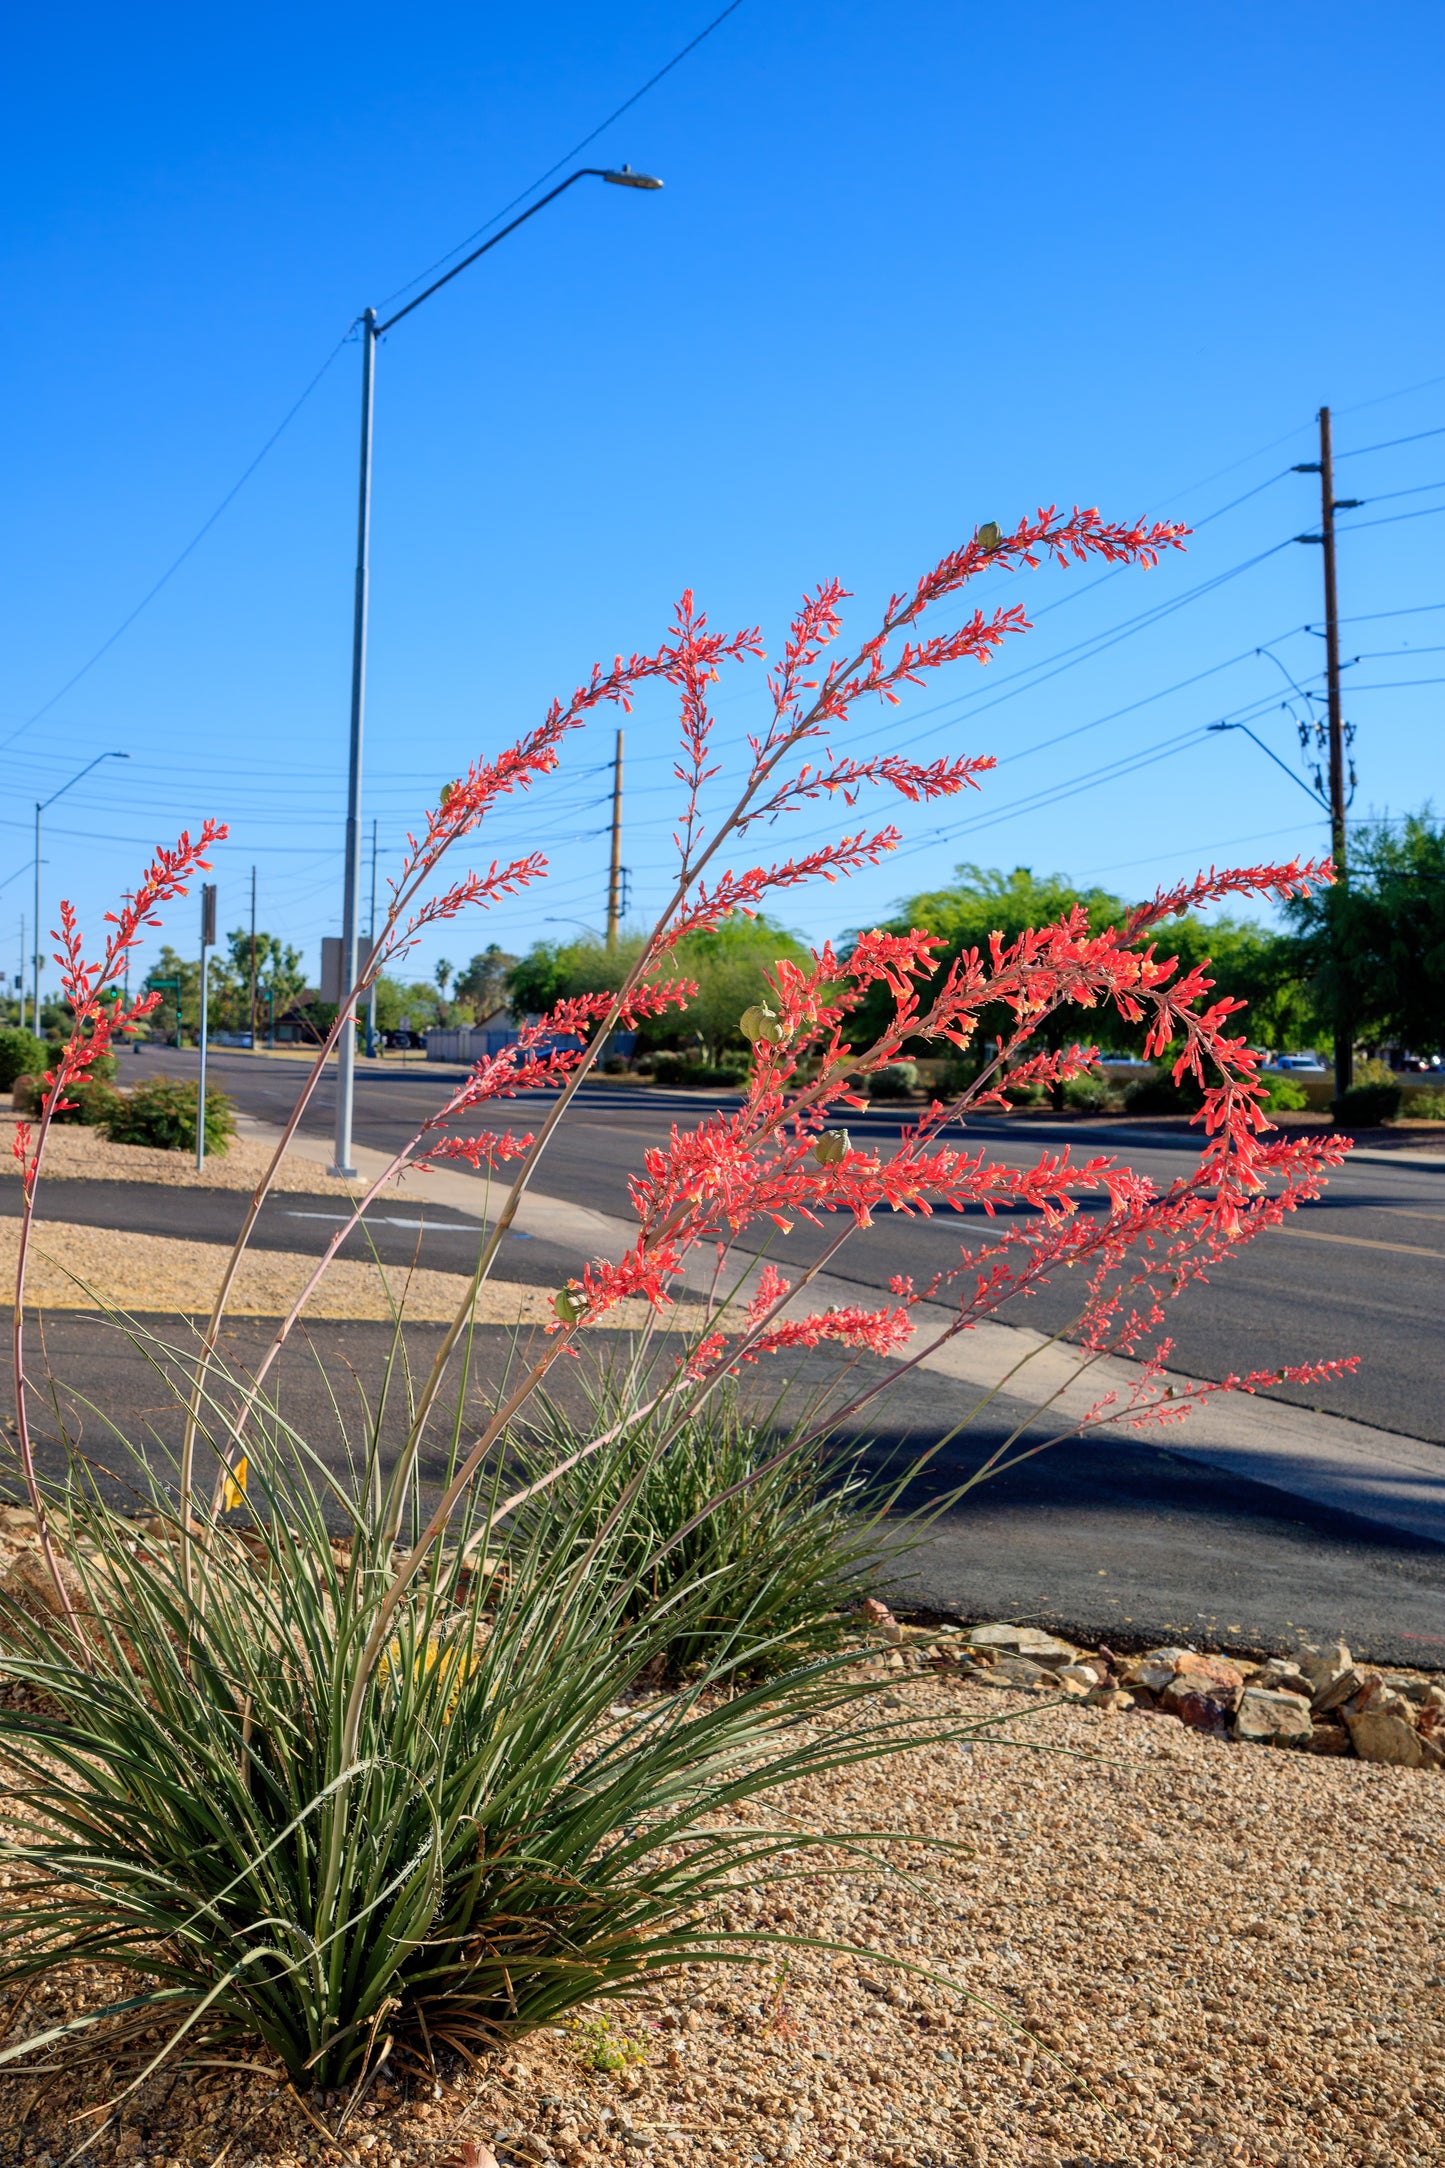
[[11, 1312, 1445, 1665]]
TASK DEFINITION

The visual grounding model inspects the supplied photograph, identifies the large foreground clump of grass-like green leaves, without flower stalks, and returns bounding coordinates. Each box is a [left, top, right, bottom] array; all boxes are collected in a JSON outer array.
[[0, 1387, 927, 2088]]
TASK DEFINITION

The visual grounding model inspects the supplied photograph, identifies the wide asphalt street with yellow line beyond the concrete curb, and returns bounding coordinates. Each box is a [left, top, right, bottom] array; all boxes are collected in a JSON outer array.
[[128, 1049, 1445, 1444]]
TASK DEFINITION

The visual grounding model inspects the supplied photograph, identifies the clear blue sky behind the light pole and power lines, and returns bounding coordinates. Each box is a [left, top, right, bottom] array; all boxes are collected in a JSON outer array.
[[0, 0, 1445, 984]]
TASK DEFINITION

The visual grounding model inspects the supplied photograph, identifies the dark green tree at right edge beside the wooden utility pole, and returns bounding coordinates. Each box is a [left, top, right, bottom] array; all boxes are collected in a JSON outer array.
[[1289, 806, 1445, 1054]]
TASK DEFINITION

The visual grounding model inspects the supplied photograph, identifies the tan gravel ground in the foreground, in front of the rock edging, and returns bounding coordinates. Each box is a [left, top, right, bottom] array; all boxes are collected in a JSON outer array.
[[0, 1674, 1445, 2168]]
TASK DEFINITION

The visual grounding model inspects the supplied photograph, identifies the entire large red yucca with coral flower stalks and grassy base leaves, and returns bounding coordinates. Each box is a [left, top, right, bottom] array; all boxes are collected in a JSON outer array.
[[0, 509, 1345, 2086]]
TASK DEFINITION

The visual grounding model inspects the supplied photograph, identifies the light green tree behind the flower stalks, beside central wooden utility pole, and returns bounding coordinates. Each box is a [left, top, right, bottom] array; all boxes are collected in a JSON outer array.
[[507, 915, 808, 1062]]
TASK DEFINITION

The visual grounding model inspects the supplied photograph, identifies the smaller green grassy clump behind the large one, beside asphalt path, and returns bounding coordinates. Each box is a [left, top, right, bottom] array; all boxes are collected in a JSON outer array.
[[520, 1383, 914, 1680]]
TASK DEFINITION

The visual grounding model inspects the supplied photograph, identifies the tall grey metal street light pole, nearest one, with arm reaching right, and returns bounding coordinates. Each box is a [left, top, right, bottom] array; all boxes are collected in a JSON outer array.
[[327, 165, 663, 1179]]
